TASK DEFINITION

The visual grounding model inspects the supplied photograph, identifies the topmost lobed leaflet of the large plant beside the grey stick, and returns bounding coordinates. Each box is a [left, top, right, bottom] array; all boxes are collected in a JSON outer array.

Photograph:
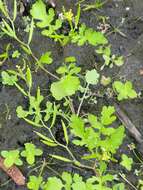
[[101, 106, 116, 125]]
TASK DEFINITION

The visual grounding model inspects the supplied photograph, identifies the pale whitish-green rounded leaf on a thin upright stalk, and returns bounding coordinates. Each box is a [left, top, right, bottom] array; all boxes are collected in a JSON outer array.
[[85, 69, 100, 85]]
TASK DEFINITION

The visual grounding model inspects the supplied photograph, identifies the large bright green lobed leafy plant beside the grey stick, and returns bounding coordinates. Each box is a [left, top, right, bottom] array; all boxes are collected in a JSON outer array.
[[70, 106, 124, 160]]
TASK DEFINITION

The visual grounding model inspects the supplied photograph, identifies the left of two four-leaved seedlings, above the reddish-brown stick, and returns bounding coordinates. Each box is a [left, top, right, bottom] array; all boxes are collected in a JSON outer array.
[[1, 150, 23, 168]]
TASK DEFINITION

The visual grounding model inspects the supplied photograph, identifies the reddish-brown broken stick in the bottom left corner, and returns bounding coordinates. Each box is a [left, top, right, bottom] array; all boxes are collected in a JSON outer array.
[[0, 157, 25, 185]]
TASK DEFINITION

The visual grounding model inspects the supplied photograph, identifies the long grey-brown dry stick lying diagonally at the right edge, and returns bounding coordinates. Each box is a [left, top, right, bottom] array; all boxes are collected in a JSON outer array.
[[114, 102, 143, 153]]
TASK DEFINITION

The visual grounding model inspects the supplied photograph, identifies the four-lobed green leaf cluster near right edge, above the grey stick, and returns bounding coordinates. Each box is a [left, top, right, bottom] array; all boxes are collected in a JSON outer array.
[[113, 81, 137, 101]]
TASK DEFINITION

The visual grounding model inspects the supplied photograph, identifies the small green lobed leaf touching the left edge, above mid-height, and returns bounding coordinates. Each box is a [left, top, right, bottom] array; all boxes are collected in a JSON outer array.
[[1, 71, 18, 86]]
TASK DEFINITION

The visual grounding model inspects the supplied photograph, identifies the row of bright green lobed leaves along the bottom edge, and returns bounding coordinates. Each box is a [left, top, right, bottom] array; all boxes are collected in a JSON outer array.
[[28, 170, 124, 190]]
